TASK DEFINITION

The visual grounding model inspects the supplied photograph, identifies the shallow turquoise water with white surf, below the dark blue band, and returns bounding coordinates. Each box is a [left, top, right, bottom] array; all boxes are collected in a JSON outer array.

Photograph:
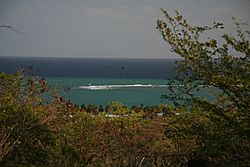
[[46, 77, 213, 106]]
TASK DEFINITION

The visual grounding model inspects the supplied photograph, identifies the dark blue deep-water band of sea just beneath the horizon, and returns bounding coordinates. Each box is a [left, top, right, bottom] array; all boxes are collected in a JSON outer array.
[[0, 57, 175, 79]]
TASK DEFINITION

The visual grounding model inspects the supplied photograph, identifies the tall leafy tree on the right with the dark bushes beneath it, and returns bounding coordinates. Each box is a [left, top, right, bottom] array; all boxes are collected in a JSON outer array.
[[157, 10, 250, 166]]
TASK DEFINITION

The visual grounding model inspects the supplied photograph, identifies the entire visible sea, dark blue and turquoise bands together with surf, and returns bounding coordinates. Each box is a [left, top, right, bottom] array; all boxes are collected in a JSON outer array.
[[0, 57, 213, 106]]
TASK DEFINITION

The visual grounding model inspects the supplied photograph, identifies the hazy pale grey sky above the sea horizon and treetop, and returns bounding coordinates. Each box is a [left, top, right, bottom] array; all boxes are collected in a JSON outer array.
[[0, 0, 250, 58]]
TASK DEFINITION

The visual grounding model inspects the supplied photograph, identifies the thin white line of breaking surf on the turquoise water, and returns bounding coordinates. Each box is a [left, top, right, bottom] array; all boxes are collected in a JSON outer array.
[[79, 84, 168, 90]]
